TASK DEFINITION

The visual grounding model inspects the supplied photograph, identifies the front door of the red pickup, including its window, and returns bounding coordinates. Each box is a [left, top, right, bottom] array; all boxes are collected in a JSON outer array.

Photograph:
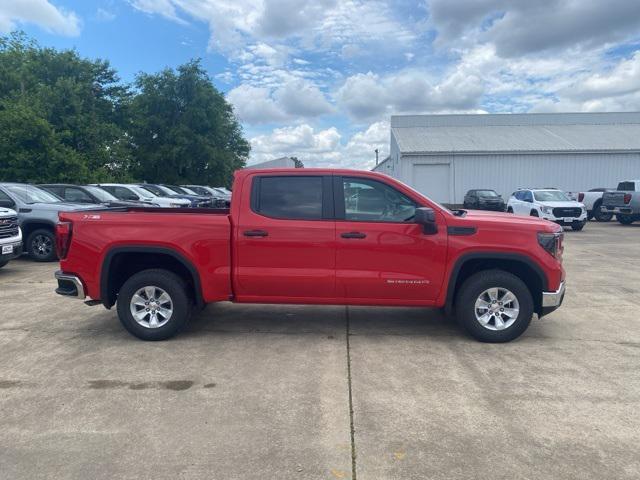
[[334, 176, 447, 305]]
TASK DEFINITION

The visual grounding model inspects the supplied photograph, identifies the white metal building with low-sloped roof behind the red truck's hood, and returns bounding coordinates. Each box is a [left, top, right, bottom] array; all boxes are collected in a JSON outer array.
[[374, 112, 640, 204]]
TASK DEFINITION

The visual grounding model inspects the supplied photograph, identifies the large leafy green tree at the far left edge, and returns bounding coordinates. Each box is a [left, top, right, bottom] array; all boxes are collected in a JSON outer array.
[[0, 33, 131, 182]]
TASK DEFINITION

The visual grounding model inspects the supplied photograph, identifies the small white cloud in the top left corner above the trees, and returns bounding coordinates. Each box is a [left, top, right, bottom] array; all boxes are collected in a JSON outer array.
[[0, 0, 80, 37]]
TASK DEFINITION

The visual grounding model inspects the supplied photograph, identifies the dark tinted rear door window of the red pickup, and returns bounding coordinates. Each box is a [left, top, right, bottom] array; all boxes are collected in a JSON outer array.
[[252, 175, 323, 220]]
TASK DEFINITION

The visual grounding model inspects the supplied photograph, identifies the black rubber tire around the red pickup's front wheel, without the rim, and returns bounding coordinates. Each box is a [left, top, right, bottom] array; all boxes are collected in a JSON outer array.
[[455, 270, 533, 343]]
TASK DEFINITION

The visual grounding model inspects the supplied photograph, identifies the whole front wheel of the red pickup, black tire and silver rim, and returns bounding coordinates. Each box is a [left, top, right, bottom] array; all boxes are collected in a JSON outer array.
[[455, 270, 533, 343]]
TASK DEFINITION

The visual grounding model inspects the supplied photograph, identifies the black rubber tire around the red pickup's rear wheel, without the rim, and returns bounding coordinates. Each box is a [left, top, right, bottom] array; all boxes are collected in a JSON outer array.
[[117, 269, 192, 341]]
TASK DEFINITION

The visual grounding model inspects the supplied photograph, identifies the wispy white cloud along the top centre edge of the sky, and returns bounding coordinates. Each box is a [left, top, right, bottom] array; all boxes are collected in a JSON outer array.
[[130, 0, 420, 56]]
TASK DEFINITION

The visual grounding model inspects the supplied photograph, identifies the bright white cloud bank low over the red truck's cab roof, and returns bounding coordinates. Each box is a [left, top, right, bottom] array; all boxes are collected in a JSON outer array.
[[250, 122, 389, 169]]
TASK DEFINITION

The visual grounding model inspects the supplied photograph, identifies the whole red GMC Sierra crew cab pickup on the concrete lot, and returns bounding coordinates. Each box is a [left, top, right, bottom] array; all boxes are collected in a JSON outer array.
[[55, 169, 565, 342]]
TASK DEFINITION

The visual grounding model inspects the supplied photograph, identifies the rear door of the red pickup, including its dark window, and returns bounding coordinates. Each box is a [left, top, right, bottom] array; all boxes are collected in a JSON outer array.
[[234, 174, 336, 303]]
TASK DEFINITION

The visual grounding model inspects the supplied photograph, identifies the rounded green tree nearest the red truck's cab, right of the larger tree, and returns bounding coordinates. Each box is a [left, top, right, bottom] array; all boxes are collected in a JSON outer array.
[[127, 60, 250, 185]]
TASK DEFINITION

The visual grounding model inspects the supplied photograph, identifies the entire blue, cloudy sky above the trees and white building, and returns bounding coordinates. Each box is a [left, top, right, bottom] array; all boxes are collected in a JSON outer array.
[[0, 0, 640, 169]]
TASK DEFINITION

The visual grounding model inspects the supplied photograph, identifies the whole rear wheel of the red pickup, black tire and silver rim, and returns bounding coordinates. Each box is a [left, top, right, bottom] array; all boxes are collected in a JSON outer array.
[[117, 269, 191, 341]]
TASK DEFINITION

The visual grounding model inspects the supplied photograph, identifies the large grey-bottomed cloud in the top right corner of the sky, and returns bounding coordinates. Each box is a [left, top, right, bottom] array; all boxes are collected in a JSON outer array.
[[428, 0, 640, 58]]
